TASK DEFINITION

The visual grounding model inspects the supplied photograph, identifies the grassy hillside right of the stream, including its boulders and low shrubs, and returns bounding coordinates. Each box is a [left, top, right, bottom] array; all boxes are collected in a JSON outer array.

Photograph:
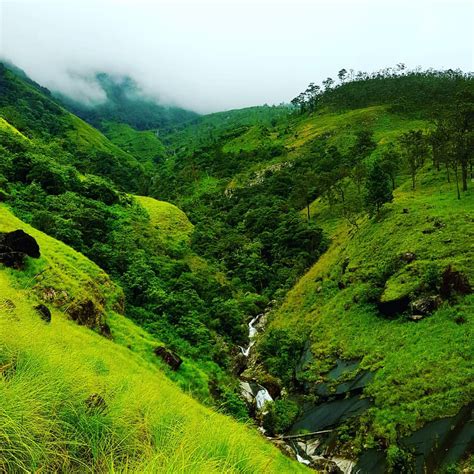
[[260, 170, 474, 466]]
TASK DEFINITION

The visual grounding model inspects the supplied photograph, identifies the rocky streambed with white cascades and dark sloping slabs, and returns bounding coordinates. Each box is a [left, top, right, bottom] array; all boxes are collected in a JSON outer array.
[[238, 308, 474, 474]]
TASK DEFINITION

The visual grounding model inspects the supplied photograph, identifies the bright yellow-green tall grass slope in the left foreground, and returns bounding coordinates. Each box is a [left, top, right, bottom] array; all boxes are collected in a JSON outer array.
[[0, 206, 304, 473]]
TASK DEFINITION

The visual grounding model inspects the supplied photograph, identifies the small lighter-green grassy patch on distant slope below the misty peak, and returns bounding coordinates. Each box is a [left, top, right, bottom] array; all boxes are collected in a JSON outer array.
[[103, 122, 165, 162]]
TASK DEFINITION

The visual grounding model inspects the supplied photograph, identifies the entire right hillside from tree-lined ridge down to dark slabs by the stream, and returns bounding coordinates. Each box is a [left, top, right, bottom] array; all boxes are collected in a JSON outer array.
[[152, 72, 474, 472]]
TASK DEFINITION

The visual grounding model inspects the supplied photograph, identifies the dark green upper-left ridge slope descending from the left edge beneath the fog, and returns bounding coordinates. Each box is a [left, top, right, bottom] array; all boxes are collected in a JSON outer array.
[[0, 63, 145, 191]]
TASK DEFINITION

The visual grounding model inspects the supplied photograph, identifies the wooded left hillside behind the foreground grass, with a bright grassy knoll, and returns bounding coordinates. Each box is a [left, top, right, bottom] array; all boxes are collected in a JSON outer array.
[[0, 70, 252, 406]]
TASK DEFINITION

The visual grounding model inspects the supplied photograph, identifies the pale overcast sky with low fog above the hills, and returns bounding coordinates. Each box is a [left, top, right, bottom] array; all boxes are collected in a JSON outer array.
[[0, 0, 474, 113]]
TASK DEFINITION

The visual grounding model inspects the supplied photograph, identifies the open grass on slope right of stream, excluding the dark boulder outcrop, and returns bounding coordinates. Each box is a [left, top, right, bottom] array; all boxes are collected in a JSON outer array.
[[264, 166, 474, 441]]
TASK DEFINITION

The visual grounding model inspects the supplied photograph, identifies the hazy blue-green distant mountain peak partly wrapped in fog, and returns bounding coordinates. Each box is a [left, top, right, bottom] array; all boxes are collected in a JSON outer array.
[[55, 73, 199, 131]]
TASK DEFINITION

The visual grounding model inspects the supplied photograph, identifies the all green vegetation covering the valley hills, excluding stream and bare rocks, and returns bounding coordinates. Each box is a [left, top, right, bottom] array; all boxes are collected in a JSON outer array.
[[0, 61, 474, 472]]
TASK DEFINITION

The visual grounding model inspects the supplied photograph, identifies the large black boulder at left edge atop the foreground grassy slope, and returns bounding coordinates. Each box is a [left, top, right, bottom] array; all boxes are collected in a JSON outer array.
[[0, 229, 40, 268]]
